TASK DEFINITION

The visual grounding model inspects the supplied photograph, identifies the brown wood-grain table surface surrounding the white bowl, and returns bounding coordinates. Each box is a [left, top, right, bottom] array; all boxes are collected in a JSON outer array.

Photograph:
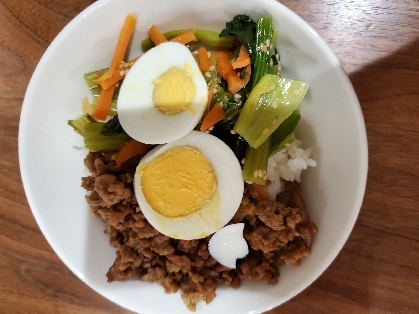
[[0, 0, 419, 314]]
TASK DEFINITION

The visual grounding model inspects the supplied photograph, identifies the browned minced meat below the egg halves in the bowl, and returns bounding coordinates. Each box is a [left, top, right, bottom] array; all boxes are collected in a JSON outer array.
[[82, 152, 317, 311]]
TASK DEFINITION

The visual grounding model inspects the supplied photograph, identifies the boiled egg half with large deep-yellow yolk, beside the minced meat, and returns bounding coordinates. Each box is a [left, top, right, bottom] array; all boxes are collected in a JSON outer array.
[[134, 131, 244, 240]]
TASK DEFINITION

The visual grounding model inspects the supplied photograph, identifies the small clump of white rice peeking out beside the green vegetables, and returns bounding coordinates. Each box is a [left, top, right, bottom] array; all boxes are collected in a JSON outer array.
[[266, 139, 316, 200]]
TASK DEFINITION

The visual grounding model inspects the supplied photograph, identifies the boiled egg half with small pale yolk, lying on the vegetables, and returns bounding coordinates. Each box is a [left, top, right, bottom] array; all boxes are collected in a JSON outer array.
[[117, 42, 208, 144]]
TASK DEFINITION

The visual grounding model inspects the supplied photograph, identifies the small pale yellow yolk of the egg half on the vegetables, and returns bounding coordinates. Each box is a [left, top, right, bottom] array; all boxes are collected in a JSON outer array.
[[152, 66, 196, 115]]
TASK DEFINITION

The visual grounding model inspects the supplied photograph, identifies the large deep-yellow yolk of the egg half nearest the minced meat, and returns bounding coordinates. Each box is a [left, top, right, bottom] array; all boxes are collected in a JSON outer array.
[[140, 146, 217, 218]]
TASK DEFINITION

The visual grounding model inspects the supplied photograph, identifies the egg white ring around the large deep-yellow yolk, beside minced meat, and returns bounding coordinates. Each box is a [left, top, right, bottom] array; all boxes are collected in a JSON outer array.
[[134, 131, 244, 240]]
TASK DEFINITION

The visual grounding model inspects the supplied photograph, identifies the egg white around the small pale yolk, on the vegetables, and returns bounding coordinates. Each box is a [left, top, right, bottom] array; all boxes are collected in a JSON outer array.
[[117, 42, 208, 144]]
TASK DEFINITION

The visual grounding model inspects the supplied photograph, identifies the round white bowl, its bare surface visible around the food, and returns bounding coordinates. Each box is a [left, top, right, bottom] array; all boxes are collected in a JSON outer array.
[[19, 0, 367, 314]]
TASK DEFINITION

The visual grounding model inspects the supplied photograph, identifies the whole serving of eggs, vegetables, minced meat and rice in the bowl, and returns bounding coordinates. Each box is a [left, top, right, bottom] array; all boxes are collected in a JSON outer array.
[[69, 15, 317, 310]]
